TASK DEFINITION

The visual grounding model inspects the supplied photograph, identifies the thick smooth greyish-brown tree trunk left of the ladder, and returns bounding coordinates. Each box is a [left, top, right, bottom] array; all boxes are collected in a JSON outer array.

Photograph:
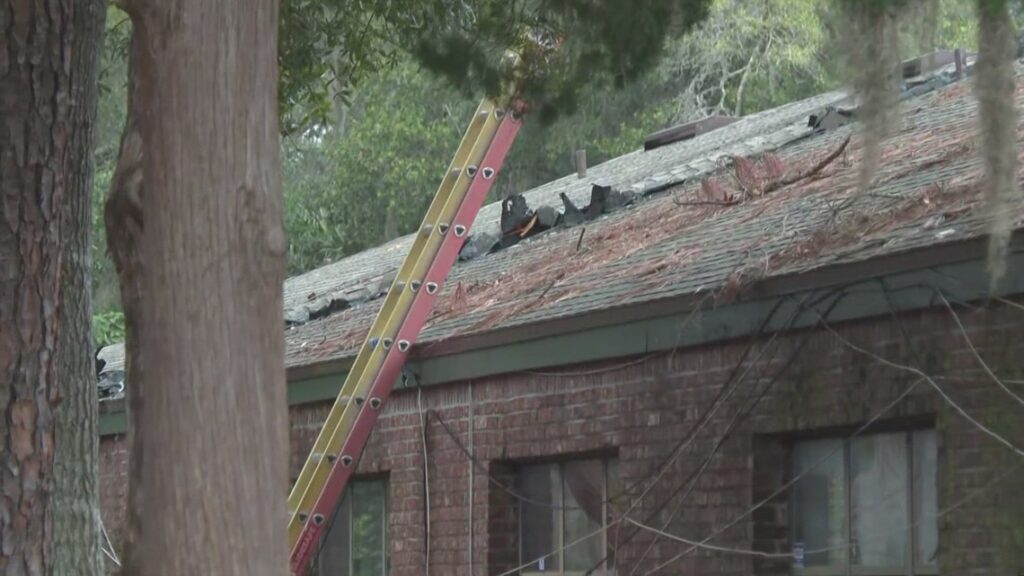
[[108, 0, 288, 576]]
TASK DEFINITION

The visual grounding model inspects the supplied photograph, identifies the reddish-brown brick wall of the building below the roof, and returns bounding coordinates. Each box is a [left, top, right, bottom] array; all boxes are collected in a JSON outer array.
[[101, 297, 1024, 576]]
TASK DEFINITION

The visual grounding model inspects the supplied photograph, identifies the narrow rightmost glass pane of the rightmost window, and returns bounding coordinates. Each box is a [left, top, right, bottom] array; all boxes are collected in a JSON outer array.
[[913, 429, 939, 566]]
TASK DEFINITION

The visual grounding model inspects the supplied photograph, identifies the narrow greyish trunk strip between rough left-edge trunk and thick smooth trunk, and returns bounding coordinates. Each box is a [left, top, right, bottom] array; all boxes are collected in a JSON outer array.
[[49, 0, 106, 576]]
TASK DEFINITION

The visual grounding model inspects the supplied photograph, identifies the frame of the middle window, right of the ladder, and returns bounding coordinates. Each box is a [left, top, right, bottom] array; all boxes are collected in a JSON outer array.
[[515, 455, 617, 576]]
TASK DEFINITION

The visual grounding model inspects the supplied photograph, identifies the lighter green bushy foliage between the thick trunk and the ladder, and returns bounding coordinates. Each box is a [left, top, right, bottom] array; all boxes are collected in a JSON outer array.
[[284, 61, 473, 272]]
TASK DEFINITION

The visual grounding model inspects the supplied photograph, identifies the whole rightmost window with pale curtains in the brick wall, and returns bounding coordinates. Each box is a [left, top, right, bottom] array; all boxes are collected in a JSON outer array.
[[791, 429, 938, 576]]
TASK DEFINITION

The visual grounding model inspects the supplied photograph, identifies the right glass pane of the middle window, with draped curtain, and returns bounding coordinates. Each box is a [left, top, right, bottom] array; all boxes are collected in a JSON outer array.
[[562, 460, 604, 572]]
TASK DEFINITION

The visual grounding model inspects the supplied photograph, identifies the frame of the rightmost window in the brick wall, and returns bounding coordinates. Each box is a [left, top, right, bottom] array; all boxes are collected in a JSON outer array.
[[786, 425, 939, 576]]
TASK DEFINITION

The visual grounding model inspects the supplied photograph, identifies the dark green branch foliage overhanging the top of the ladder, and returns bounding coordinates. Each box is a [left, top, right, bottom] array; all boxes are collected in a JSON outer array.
[[413, 0, 712, 124]]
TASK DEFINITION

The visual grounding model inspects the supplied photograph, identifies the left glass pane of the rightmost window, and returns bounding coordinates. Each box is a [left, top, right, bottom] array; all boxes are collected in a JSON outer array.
[[793, 440, 847, 567]]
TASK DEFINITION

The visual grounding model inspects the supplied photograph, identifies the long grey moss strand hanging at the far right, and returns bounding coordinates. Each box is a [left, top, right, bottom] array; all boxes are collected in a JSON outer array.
[[975, 0, 1017, 289]]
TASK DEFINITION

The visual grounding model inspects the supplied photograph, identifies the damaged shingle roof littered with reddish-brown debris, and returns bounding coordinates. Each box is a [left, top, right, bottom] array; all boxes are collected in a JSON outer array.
[[102, 58, 1024, 385]]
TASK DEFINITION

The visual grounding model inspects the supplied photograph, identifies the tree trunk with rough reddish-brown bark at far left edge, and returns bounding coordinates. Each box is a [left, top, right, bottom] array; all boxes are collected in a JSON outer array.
[[0, 0, 103, 576]]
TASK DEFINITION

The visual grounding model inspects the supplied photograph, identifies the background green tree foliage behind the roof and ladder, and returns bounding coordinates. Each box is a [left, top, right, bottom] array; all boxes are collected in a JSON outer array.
[[92, 0, 995, 313]]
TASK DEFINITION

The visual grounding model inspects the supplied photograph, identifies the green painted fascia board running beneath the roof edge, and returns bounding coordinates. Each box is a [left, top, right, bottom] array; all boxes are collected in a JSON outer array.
[[99, 253, 1024, 435]]
